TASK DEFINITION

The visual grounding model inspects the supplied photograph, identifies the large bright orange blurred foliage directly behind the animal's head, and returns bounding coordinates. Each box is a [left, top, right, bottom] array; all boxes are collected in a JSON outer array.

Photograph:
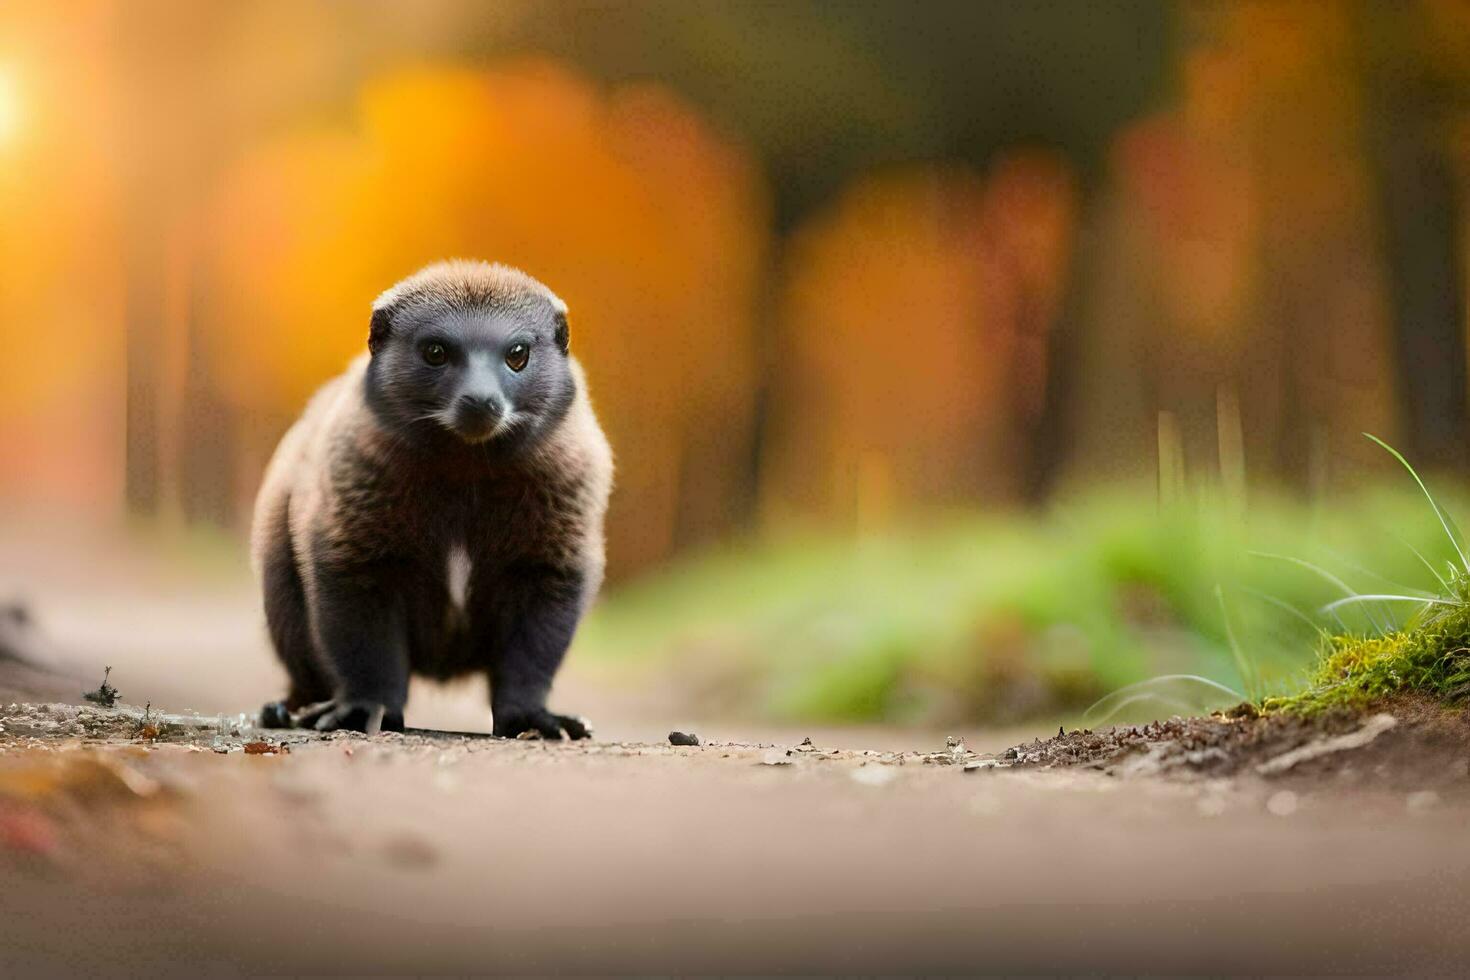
[[203, 60, 767, 575]]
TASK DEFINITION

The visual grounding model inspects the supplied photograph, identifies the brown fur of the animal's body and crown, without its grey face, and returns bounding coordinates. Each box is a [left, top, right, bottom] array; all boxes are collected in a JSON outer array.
[[251, 262, 613, 732]]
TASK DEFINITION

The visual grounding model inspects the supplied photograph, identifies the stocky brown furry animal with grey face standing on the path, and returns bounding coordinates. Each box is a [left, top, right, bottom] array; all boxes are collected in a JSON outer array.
[[251, 262, 613, 739]]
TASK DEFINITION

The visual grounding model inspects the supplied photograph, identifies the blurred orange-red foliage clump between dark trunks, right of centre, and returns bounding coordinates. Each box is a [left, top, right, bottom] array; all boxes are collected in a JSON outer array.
[[763, 154, 1075, 522]]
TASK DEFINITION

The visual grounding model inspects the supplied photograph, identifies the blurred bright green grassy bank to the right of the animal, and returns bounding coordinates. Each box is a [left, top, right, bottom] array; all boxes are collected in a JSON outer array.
[[579, 485, 1455, 723]]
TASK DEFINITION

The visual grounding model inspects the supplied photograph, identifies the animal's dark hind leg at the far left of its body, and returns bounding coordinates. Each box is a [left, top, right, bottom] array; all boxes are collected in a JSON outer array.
[[260, 508, 332, 727]]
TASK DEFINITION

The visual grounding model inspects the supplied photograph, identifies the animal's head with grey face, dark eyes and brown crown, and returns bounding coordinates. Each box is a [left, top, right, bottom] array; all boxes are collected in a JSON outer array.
[[368, 262, 576, 450]]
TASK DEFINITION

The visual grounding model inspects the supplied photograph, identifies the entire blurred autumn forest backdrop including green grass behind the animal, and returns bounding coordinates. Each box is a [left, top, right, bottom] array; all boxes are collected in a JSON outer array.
[[0, 0, 1470, 723]]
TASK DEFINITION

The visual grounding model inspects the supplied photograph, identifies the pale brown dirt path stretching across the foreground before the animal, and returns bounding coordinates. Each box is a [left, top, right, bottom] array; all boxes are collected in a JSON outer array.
[[0, 696, 1470, 974]]
